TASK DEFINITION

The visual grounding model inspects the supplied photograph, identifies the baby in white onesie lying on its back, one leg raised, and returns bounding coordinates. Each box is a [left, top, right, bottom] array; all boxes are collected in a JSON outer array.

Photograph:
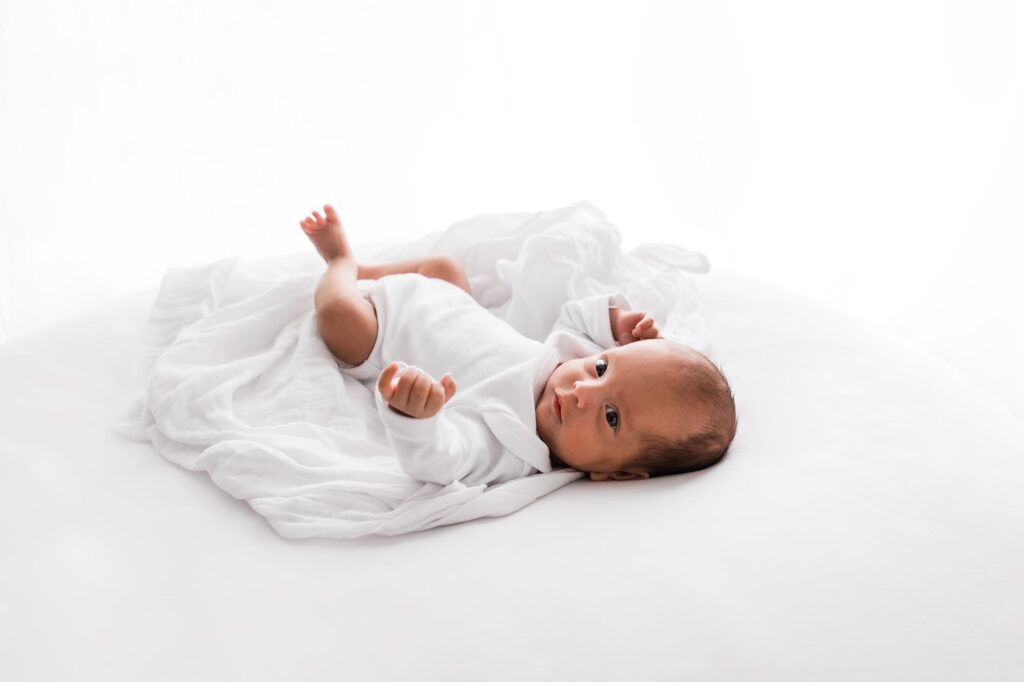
[[300, 205, 736, 484]]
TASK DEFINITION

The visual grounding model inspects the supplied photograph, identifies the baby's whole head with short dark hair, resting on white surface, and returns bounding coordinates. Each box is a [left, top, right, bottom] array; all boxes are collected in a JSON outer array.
[[537, 339, 736, 480]]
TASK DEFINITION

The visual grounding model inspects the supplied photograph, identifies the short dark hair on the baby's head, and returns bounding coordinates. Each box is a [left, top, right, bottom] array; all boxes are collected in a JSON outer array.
[[630, 341, 738, 477]]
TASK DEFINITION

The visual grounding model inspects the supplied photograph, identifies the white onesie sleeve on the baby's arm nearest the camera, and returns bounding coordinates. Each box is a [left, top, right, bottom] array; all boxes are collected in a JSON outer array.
[[374, 376, 490, 485]]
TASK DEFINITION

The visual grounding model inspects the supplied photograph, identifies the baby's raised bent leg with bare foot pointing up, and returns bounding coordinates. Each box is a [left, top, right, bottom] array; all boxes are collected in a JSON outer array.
[[300, 205, 377, 366]]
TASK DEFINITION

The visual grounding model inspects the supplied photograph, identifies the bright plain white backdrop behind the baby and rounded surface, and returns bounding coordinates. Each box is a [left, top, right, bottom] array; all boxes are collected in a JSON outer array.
[[0, 0, 1024, 415]]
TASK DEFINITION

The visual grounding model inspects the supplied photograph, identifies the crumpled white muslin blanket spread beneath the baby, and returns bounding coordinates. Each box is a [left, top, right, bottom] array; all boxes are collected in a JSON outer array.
[[116, 203, 709, 538]]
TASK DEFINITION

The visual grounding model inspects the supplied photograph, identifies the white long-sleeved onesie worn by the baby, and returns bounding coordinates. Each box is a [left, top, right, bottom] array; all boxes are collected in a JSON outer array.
[[338, 273, 630, 485]]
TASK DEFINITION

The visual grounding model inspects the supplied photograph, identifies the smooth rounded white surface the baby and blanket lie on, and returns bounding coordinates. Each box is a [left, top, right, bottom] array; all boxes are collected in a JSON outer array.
[[0, 266, 1024, 682]]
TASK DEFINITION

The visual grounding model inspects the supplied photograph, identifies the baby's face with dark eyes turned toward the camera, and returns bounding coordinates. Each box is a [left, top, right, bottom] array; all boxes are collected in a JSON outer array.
[[536, 339, 700, 478]]
